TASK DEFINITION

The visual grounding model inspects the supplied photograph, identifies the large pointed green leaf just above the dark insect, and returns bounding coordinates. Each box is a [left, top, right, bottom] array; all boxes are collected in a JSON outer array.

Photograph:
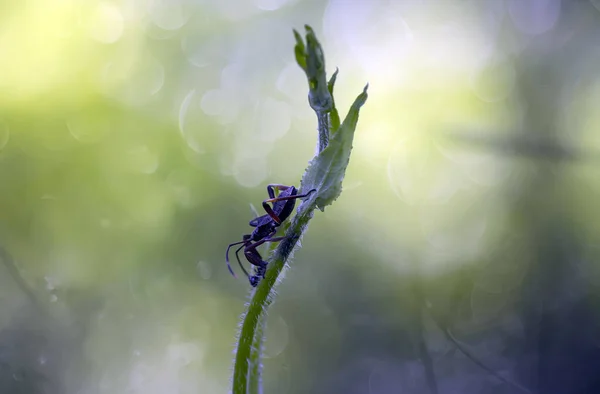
[[301, 85, 369, 211]]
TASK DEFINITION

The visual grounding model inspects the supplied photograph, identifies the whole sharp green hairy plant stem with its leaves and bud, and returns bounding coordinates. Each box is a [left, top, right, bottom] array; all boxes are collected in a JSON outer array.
[[233, 26, 367, 394]]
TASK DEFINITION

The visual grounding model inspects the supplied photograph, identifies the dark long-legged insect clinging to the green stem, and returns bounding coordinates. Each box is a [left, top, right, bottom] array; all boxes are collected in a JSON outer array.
[[225, 184, 317, 287]]
